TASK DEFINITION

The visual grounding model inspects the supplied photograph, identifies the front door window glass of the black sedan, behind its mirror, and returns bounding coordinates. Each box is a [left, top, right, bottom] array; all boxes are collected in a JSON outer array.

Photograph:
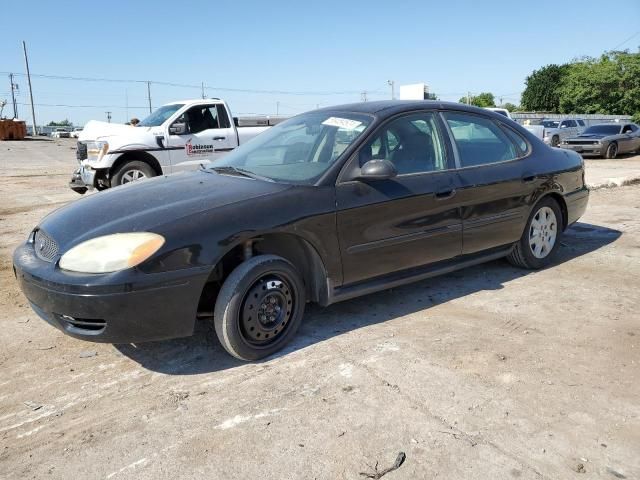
[[358, 113, 447, 175]]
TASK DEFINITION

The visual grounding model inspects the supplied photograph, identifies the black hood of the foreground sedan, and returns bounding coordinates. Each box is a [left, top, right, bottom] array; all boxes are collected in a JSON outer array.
[[39, 170, 289, 252]]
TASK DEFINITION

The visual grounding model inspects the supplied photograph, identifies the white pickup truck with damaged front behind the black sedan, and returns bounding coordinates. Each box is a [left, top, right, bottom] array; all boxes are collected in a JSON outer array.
[[69, 99, 277, 194]]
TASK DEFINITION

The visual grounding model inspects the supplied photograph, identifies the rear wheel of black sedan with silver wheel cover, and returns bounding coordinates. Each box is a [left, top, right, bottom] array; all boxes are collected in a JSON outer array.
[[507, 197, 564, 270]]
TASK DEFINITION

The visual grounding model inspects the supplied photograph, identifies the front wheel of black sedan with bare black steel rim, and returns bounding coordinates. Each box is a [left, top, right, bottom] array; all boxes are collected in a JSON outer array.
[[213, 255, 305, 361]]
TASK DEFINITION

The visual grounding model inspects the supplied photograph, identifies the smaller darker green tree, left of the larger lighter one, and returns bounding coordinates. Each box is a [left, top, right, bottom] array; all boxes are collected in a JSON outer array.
[[521, 64, 569, 112]]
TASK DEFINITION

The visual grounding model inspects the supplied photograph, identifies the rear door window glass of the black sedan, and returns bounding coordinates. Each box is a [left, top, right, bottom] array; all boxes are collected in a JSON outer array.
[[443, 112, 526, 168]]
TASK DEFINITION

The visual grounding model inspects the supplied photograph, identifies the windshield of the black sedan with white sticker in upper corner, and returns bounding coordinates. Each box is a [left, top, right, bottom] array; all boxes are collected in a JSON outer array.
[[212, 112, 373, 185]]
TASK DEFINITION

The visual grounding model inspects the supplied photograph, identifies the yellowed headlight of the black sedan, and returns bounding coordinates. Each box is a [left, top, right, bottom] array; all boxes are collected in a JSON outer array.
[[60, 232, 164, 273]]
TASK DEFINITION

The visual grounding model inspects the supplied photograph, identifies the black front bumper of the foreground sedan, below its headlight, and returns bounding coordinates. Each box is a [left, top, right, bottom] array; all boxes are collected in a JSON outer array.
[[13, 242, 209, 343]]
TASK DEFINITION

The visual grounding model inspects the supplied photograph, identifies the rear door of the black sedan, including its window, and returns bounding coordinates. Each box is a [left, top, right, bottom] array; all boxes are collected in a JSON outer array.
[[442, 111, 541, 254]]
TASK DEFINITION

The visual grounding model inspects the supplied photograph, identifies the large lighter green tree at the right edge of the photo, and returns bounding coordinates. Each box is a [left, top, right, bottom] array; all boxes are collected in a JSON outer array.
[[558, 51, 640, 115]]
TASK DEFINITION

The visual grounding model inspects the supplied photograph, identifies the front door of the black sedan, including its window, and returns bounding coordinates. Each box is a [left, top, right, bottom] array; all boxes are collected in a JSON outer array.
[[336, 112, 462, 284]]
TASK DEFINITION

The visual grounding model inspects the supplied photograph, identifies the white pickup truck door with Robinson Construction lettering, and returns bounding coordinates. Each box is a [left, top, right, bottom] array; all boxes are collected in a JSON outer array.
[[168, 104, 237, 173]]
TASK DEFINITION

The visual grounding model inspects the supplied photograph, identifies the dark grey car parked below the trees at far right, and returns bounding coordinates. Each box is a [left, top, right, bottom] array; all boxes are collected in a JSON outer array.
[[560, 123, 640, 158]]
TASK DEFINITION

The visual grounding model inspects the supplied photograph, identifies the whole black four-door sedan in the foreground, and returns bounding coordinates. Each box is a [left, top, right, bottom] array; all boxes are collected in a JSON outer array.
[[13, 101, 589, 360]]
